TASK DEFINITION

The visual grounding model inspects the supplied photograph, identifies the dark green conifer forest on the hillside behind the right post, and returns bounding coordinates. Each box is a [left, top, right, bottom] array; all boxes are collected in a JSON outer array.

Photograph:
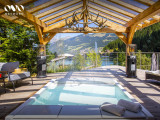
[[103, 23, 160, 52]]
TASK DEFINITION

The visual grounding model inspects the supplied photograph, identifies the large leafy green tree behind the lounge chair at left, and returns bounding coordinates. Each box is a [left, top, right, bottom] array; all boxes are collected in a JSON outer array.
[[0, 19, 39, 72]]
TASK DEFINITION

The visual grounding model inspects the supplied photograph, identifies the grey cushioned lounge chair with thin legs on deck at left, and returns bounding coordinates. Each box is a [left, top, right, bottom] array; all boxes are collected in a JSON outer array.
[[0, 62, 33, 91]]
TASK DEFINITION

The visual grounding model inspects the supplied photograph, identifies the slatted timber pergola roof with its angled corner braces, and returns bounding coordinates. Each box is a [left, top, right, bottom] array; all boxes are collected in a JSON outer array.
[[0, 0, 160, 44]]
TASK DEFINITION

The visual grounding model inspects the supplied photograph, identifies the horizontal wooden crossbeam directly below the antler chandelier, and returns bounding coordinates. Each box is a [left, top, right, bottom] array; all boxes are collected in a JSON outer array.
[[46, 28, 115, 33]]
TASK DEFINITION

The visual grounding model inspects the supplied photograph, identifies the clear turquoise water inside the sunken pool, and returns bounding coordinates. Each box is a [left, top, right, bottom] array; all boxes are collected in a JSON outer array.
[[30, 84, 131, 105]]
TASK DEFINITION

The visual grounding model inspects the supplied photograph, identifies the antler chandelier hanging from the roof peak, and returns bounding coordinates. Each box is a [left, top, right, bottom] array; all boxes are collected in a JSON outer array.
[[65, 0, 107, 32]]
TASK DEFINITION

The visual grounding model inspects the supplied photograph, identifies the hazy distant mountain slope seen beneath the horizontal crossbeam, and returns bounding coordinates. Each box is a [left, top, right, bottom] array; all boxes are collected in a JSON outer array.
[[49, 33, 118, 54]]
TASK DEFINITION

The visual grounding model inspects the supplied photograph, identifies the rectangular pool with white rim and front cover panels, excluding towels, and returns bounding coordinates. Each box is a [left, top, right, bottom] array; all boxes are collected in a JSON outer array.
[[5, 78, 153, 120]]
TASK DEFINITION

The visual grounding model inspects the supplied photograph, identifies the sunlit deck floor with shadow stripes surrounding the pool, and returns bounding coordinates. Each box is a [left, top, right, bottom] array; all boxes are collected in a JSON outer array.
[[0, 66, 160, 120]]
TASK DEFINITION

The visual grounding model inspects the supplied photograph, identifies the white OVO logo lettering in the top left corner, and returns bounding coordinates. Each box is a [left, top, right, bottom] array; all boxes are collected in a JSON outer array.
[[4, 5, 24, 16]]
